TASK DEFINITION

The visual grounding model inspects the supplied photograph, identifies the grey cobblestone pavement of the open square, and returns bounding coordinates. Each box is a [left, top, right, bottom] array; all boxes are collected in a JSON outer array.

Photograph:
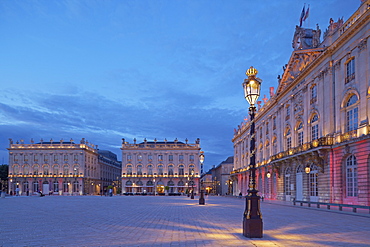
[[0, 196, 370, 247]]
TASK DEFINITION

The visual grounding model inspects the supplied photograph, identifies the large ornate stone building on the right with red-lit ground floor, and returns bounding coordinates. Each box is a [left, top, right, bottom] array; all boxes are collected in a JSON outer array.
[[232, 0, 370, 205]]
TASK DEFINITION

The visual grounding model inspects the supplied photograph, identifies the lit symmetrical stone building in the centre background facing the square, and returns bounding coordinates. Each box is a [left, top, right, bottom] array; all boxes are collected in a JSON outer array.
[[121, 139, 201, 195]]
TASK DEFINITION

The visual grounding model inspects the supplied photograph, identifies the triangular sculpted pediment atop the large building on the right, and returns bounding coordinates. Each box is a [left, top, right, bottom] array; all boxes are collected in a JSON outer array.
[[276, 48, 324, 94]]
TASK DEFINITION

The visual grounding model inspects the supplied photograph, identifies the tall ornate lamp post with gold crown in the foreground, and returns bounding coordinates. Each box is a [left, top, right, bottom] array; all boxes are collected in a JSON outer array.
[[242, 66, 263, 238]]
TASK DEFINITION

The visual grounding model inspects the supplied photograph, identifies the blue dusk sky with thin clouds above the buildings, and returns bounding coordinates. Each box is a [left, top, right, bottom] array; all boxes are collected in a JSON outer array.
[[0, 0, 361, 170]]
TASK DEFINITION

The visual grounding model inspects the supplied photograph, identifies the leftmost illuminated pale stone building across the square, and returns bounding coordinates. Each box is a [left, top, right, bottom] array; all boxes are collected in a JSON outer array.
[[8, 138, 117, 195]]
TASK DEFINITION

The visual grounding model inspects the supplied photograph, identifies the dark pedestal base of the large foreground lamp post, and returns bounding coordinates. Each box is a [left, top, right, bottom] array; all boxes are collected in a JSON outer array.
[[243, 193, 263, 238]]
